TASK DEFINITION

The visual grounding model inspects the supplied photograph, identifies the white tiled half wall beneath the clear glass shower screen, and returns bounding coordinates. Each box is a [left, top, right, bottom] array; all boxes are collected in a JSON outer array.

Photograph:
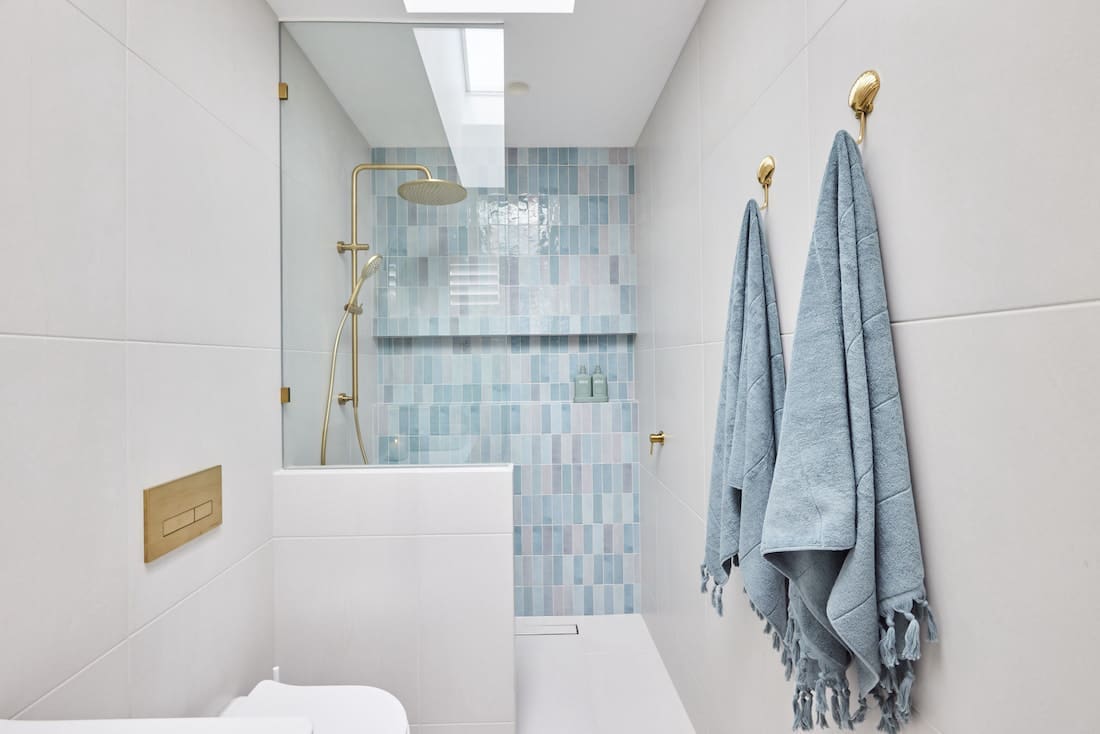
[[273, 465, 516, 734]]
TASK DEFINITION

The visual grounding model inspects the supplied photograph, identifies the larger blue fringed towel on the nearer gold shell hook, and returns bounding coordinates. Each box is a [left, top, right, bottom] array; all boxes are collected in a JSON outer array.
[[763, 132, 936, 734]]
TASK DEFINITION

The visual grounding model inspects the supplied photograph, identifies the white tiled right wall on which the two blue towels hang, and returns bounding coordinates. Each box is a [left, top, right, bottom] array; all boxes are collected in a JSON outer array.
[[636, 0, 1100, 734]]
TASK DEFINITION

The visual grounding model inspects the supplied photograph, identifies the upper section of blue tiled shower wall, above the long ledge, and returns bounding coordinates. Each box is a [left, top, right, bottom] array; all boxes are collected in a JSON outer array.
[[372, 147, 637, 337]]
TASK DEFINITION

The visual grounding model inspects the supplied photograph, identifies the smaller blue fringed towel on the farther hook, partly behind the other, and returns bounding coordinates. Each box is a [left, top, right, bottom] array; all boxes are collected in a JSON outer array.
[[702, 200, 788, 662]]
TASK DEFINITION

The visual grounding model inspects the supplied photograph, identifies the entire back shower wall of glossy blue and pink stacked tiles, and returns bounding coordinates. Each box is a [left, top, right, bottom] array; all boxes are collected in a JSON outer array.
[[372, 149, 640, 615]]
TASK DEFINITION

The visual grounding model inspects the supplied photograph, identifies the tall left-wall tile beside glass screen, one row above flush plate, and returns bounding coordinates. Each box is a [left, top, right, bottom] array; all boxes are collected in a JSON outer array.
[[127, 54, 279, 348]]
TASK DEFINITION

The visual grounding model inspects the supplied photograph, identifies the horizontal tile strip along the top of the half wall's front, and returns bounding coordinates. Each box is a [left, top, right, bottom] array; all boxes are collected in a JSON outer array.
[[274, 464, 513, 537]]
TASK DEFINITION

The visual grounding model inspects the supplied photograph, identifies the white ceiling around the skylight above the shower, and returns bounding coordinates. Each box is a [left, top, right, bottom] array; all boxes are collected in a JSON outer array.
[[267, 0, 705, 146]]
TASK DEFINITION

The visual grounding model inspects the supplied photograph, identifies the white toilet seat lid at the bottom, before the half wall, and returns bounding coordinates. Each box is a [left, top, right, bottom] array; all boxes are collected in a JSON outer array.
[[221, 680, 409, 734]]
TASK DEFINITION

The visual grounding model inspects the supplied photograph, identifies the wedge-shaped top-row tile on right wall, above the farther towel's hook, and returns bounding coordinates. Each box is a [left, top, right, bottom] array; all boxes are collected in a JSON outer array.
[[697, 0, 816, 152]]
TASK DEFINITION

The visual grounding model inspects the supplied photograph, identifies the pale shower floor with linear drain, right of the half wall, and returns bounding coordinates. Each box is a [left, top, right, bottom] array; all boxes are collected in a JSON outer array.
[[516, 614, 695, 734]]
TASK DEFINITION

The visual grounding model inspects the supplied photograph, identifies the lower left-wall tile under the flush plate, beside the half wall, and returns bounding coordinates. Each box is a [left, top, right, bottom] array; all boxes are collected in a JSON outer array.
[[130, 544, 274, 717]]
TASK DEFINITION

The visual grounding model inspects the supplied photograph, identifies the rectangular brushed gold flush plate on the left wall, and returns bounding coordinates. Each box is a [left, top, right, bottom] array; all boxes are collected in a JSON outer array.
[[144, 465, 221, 563]]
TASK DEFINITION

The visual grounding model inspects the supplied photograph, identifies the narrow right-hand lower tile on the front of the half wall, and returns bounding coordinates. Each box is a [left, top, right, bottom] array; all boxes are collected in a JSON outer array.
[[416, 533, 516, 724]]
